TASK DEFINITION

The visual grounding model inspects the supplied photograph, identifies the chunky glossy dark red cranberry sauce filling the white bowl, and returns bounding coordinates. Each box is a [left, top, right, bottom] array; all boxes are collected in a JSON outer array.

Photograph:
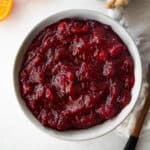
[[19, 18, 134, 130]]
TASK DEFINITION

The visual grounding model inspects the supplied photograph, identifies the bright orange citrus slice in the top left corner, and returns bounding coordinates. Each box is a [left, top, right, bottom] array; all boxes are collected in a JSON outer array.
[[0, 0, 13, 21]]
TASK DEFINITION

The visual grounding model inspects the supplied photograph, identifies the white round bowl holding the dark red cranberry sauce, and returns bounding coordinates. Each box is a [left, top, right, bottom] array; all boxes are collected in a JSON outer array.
[[13, 9, 142, 140]]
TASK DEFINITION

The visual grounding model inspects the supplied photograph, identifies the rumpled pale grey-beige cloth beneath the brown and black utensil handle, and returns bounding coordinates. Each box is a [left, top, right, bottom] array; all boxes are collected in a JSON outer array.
[[108, 0, 150, 137]]
